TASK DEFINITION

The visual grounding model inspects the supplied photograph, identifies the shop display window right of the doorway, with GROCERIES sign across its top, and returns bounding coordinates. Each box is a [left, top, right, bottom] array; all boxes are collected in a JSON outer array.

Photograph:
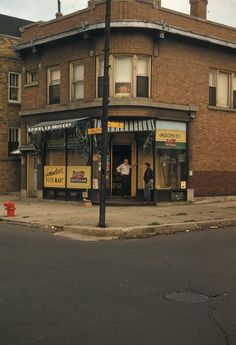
[[156, 121, 187, 189]]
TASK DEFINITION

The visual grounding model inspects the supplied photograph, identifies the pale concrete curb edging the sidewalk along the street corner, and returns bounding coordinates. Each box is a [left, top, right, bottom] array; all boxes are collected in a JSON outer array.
[[1, 218, 236, 239]]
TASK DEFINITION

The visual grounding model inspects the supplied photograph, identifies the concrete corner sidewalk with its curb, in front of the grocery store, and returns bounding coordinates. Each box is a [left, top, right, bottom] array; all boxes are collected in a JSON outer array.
[[0, 196, 236, 238]]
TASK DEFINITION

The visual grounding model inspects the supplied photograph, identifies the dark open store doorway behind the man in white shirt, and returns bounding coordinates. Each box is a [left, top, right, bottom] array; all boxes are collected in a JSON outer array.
[[112, 145, 132, 196]]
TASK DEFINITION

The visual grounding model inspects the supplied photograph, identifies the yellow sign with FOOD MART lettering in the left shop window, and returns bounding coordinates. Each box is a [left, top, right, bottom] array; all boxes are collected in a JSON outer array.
[[44, 166, 65, 188]]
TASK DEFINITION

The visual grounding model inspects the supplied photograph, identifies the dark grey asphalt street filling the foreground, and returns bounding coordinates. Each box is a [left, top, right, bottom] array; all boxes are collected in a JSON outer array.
[[0, 223, 236, 345]]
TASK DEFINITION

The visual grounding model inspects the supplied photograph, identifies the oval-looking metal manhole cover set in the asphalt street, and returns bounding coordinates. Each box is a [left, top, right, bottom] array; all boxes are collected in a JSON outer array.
[[164, 291, 209, 303]]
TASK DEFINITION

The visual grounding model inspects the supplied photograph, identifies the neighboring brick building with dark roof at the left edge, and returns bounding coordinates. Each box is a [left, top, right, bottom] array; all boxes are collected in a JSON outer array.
[[0, 14, 29, 194]]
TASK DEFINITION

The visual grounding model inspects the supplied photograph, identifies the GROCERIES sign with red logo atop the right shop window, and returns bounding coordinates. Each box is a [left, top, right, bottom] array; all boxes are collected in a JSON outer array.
[[156, 128, 186, 149]]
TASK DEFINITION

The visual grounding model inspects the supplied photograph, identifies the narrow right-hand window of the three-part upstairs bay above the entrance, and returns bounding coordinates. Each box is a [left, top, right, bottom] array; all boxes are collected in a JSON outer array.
[[136, 58, 149, 97]]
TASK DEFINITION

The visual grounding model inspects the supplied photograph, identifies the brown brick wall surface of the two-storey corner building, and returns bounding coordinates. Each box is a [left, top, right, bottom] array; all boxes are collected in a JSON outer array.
[[18, 1, 236, 195]]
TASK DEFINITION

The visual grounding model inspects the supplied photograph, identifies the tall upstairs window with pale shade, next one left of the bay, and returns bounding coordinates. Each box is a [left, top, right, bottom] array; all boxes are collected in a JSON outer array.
[[71, 62, 84, 100]]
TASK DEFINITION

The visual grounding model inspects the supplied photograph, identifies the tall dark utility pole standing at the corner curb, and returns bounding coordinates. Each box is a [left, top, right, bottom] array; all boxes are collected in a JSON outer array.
[[98, 0, 111, 228]]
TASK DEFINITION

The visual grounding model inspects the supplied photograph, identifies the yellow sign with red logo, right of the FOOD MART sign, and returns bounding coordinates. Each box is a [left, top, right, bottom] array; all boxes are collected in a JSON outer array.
[[67, 166, 91, 189]]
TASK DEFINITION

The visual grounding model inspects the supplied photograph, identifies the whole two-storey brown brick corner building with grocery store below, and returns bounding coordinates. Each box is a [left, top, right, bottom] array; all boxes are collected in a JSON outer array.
[[17, 0, 236, 201]]
